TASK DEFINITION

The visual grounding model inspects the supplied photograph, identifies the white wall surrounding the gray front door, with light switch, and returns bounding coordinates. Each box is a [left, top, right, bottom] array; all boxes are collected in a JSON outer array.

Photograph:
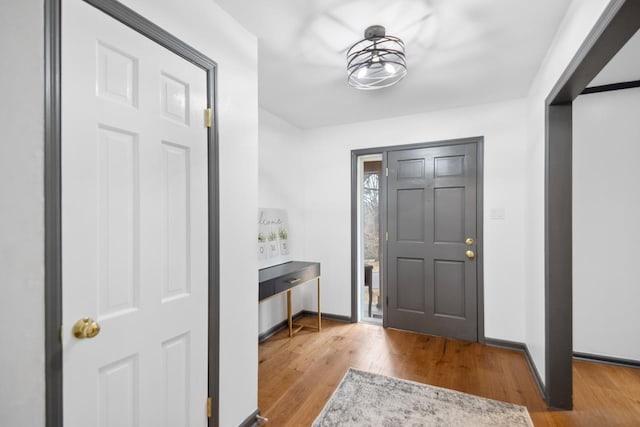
[[304, 100, 526, 341]]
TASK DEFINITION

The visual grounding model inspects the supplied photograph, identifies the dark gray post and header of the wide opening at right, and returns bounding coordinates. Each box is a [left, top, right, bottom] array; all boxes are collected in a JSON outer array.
[[544, 0, 640, 409]]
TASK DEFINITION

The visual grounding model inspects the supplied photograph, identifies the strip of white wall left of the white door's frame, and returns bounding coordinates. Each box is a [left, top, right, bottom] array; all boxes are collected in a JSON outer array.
[[0, 1, 44, 427]]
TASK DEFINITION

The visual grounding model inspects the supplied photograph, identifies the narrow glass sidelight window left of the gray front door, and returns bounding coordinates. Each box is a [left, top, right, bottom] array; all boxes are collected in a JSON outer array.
[[358, 154, 383, 325]]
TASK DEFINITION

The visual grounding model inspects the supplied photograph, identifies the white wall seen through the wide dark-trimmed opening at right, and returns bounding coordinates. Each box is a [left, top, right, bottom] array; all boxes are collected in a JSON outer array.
[[573, 88, 640, 360]]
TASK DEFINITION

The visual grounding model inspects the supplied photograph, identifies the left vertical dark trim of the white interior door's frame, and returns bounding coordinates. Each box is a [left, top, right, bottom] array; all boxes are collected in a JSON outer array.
[[43, 0, 63, 427]]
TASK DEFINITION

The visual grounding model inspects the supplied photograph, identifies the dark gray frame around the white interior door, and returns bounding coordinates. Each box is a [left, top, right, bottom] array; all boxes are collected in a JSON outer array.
[[44, 0, 220, 427]]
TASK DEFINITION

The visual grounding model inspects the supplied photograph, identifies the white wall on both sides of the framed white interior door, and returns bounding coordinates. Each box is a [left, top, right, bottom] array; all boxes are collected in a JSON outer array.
[[0, 0, 258, 427]]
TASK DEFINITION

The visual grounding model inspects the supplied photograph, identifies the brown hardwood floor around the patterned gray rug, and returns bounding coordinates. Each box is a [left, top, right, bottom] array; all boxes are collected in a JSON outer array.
[[258, 318, 640, 427]]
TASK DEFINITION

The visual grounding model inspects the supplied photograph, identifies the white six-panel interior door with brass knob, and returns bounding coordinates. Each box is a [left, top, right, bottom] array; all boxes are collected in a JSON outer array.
[[62, 0, 208, 427]]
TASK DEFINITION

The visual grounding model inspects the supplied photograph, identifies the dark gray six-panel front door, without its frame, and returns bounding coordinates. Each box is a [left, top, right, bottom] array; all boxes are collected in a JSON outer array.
[[387, 143, 477, 341]]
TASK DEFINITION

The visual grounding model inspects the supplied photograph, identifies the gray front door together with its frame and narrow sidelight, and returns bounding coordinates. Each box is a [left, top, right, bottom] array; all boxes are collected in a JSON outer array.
[[352, 138, 484, 341]]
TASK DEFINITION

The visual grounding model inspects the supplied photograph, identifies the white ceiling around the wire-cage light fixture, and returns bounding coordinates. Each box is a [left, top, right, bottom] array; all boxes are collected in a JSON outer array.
[[216, 0, 570, 128]]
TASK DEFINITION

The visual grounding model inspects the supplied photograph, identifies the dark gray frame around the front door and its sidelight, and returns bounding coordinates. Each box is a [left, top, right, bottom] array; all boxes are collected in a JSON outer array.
[[351, 136, 485, 343]]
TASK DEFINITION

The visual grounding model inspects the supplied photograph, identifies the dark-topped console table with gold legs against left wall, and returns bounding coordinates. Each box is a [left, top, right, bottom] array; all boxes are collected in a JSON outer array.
[[258, 261, 322, 337]]
